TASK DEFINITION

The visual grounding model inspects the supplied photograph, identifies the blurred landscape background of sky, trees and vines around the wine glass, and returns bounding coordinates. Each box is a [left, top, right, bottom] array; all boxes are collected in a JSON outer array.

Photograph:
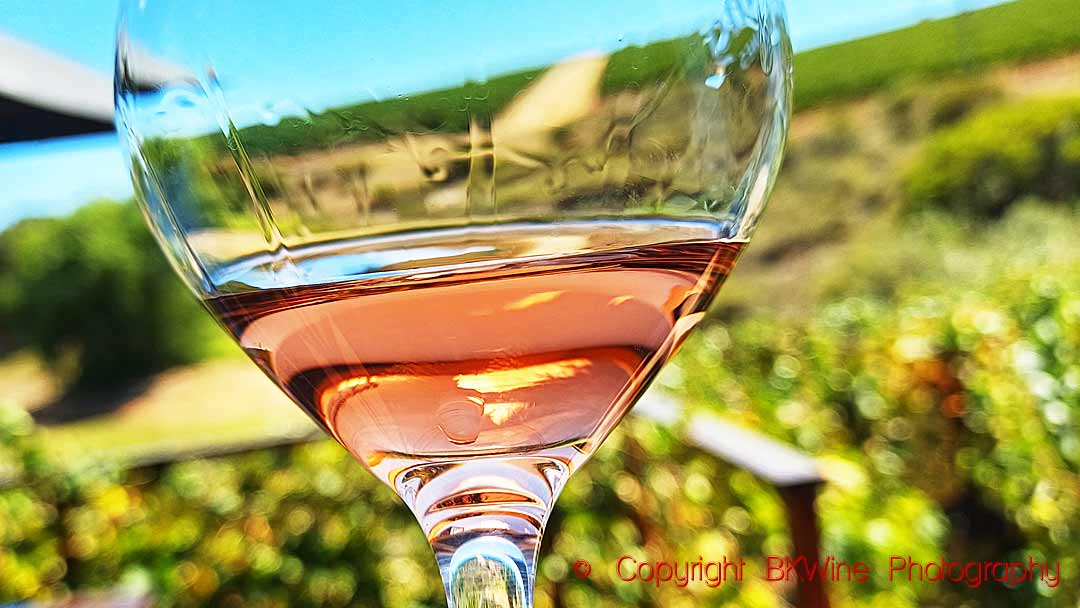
[[0, 0, 1080, 607]]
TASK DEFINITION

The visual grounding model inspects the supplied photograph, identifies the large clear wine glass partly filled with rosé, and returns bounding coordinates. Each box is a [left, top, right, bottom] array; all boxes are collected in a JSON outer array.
[[116, 0, 791, 608]]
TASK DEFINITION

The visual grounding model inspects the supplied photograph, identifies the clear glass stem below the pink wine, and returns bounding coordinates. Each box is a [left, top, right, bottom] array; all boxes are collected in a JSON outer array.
[[395, 456, 568, 608]]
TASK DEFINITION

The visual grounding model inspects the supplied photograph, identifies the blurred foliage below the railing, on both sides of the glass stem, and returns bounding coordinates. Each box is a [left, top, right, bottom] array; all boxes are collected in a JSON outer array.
[[0, 408, 803, 606]]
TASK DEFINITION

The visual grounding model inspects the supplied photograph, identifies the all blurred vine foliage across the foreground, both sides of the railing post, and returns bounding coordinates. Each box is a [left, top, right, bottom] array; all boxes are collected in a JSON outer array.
[[6, 203, 1080, 607]]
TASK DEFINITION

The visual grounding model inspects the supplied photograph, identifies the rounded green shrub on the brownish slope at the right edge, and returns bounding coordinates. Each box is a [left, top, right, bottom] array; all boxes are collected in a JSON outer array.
[[903, 98, 1080, 217]]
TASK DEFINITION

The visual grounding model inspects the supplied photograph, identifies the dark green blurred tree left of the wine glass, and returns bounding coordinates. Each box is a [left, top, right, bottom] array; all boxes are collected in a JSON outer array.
[[0, 202, 227, 386]]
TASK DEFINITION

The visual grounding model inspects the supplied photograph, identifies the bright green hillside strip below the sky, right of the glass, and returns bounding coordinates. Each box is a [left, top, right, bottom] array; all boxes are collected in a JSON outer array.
[[795, 0, 1080, 108]]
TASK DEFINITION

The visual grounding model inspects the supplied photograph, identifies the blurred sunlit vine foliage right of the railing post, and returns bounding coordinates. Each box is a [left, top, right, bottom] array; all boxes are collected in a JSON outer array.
[[669, 234, 1080, 606]]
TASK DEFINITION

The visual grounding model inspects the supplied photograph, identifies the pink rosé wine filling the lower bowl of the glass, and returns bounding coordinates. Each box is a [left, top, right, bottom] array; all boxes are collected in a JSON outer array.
[[206, 220, 742, 583]]
